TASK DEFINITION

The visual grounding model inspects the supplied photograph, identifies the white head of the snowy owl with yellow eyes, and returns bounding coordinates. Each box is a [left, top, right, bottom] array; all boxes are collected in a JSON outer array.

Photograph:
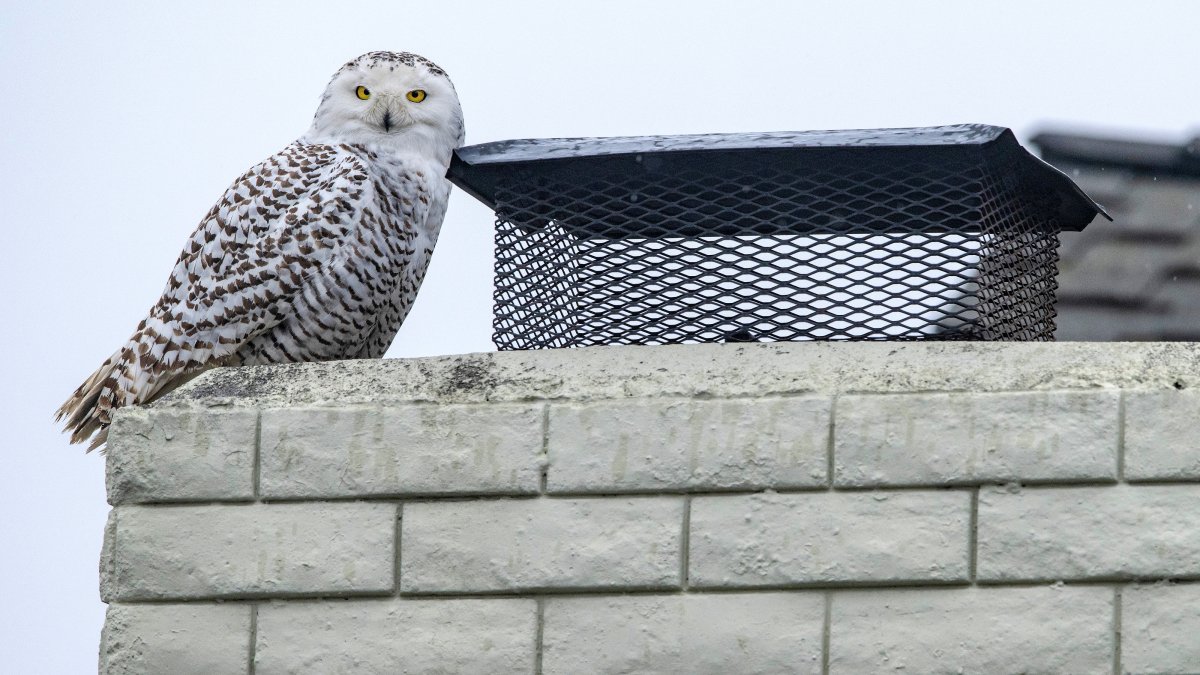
[[305, 52, 466, 163]]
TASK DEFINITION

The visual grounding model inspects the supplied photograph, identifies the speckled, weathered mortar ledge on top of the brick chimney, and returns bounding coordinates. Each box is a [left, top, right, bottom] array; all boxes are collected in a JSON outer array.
[[154, 342, 1200, 408]]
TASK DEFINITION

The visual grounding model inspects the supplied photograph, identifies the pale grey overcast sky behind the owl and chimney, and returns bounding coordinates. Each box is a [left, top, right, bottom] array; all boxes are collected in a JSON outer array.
[[0, 0, 1200, 673]]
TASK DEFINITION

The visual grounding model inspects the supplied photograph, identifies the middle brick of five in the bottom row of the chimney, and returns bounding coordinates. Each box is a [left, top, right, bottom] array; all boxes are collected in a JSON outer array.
[[542, 593, 824, 675]]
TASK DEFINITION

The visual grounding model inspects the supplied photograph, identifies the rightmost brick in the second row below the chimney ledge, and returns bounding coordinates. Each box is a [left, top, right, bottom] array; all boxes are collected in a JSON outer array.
[[978, 485, 1200, 581]]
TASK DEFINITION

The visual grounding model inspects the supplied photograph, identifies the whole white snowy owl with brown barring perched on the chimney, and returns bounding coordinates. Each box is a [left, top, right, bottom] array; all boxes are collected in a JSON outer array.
[[55, 52, 464, 449]]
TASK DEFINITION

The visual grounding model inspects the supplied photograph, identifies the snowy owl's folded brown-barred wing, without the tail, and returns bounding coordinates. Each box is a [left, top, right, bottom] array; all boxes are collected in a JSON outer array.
[[159, 143, 374, 360]]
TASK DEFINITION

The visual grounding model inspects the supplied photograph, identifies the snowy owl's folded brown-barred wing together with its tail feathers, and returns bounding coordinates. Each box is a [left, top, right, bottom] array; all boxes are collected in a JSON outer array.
[[56, 143, 374, 447]]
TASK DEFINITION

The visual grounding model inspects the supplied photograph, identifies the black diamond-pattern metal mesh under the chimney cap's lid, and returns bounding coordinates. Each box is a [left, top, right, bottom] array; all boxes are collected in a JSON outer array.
[[493, 151, 1060, 350]]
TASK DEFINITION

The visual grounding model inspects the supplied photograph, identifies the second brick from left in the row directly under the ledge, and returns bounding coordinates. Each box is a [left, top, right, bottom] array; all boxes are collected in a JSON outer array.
[[260, 405, 542, 498]]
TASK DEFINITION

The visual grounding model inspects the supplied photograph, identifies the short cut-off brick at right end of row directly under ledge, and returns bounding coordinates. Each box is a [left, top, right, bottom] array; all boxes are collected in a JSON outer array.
[[1124, 389, 1200, 480]]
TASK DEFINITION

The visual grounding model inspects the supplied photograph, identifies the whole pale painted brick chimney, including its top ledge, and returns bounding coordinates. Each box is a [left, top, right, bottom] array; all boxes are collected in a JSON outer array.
[[101, 344, 1200, 675]]
